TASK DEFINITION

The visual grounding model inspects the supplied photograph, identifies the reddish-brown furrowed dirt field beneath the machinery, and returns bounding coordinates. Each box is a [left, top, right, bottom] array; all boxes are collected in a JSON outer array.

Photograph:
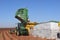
[[0, 28, 55, 40]]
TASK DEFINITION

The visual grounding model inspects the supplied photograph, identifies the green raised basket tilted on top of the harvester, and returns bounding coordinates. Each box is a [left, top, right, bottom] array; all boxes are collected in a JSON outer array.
[[15, 8, 28, 22]]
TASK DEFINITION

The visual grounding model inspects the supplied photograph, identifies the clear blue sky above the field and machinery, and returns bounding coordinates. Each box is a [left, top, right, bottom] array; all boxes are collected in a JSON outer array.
[[0, 0, 60, 27]]
